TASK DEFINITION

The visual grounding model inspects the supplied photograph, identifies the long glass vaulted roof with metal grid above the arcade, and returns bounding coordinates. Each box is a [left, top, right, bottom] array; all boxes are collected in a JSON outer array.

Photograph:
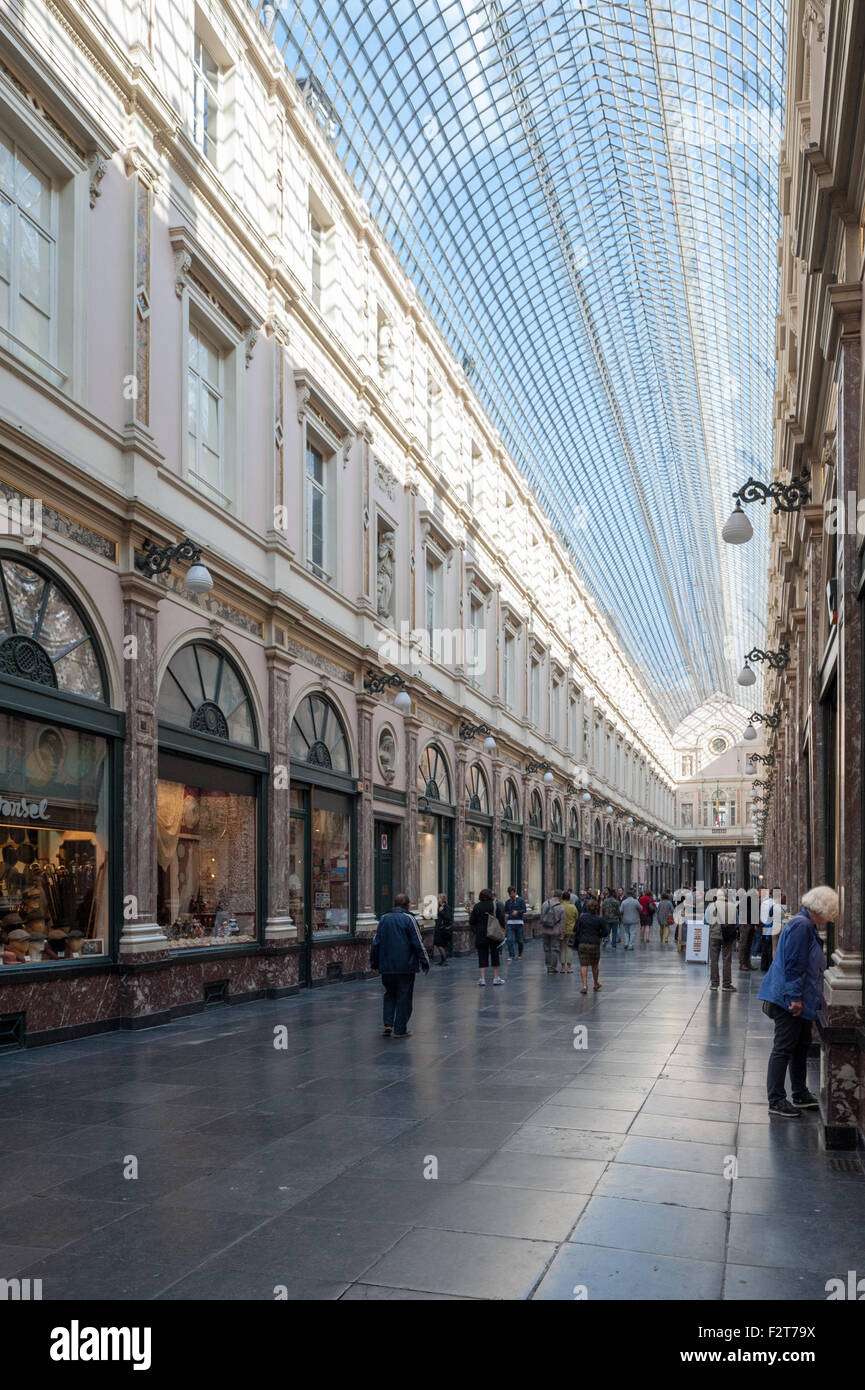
[[250, 0, 786, 726]]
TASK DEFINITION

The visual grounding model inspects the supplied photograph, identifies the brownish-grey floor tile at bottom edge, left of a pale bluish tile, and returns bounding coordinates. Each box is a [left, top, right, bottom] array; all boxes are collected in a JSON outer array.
[[363, 1230, 556, 1300]]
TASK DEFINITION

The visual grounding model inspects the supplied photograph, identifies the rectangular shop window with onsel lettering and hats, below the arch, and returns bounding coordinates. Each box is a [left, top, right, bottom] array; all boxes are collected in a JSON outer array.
[[0, 713, 110, 966]]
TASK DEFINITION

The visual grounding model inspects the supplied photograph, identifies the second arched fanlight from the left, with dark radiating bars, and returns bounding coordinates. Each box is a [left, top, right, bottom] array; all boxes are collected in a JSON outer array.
[[159, 642, 259, 748]]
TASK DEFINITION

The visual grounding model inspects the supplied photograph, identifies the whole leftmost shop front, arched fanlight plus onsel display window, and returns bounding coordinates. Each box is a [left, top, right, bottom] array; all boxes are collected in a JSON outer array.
[[0, 555, 124, 989]]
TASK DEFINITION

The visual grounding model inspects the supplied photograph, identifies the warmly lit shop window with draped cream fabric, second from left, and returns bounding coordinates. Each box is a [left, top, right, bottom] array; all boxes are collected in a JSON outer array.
[[157, 753, 257, 951]]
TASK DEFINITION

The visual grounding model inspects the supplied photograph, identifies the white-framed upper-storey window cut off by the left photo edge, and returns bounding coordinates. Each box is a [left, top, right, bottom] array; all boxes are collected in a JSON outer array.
[[0, 131, 57, 361]]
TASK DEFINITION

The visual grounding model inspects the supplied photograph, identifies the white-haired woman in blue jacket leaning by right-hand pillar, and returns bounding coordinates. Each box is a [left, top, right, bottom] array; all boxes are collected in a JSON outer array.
[[758, 887, 839, 1119]]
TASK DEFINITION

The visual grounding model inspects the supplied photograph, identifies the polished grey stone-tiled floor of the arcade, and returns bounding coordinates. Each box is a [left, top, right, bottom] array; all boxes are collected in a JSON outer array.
[[0, 942, 865, 1300]]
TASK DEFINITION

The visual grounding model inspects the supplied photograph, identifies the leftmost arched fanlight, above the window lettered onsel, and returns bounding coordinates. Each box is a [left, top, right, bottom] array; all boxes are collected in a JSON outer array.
[[0, 556, 107, 703]]
